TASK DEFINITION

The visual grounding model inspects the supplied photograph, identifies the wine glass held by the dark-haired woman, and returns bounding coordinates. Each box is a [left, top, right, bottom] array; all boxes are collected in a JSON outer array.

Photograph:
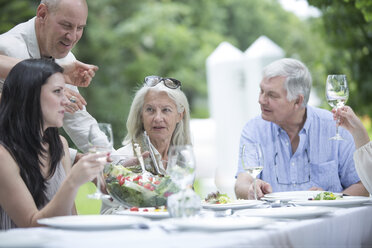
[[88, 123, 114, 199]]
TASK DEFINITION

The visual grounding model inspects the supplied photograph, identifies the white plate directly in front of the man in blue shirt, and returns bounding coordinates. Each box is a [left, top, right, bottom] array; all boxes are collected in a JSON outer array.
[[261, 191, 341, 201]]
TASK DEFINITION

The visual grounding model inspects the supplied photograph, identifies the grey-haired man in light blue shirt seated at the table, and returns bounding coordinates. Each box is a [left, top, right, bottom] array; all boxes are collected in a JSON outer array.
[[235, 58, 368, 199]]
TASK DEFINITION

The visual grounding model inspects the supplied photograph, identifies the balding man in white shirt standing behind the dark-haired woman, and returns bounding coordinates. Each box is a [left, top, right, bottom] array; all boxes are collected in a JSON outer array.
[[0, 0, 107, 159]]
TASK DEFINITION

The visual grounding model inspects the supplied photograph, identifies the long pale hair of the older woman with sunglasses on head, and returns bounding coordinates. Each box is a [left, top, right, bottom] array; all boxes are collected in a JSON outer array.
[[123, 83, 191, 146]]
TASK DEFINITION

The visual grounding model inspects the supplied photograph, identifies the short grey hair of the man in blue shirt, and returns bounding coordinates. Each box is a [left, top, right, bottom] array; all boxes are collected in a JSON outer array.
[[263, 58, 312, 107]]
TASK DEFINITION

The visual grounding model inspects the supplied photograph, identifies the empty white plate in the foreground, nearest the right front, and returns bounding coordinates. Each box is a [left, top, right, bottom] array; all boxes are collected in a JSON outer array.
[[234, 207, 333, 218]]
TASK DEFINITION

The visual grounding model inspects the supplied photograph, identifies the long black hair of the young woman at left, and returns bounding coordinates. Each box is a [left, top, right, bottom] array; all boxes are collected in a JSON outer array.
[[0, 59, 64, 207]]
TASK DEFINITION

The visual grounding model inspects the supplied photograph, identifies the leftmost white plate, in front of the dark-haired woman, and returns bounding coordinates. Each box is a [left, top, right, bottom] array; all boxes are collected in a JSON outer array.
[[37, 215, 147, 229]]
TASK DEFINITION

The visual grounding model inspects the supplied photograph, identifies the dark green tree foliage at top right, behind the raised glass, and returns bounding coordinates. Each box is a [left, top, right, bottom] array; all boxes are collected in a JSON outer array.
[[309, 0, 372, 116]]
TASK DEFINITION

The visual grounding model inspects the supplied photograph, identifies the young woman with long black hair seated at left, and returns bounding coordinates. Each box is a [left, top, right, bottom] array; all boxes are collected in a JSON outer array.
[[0, 59, 107, 229]]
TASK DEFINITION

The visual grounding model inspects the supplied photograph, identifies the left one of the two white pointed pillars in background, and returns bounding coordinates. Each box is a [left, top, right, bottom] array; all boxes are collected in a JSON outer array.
[[206, 42, 245, 200]]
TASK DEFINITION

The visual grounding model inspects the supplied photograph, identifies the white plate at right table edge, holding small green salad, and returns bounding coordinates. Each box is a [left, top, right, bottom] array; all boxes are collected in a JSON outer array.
[[290, 196, 372, 207]]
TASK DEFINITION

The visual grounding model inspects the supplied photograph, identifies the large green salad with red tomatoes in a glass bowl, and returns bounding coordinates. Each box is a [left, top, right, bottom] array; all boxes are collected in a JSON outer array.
[[105, 165, 179, 207]]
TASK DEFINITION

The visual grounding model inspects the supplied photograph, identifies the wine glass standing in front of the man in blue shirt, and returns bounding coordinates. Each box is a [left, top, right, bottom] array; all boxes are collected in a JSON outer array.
[[240, 143, 264, 200]]
